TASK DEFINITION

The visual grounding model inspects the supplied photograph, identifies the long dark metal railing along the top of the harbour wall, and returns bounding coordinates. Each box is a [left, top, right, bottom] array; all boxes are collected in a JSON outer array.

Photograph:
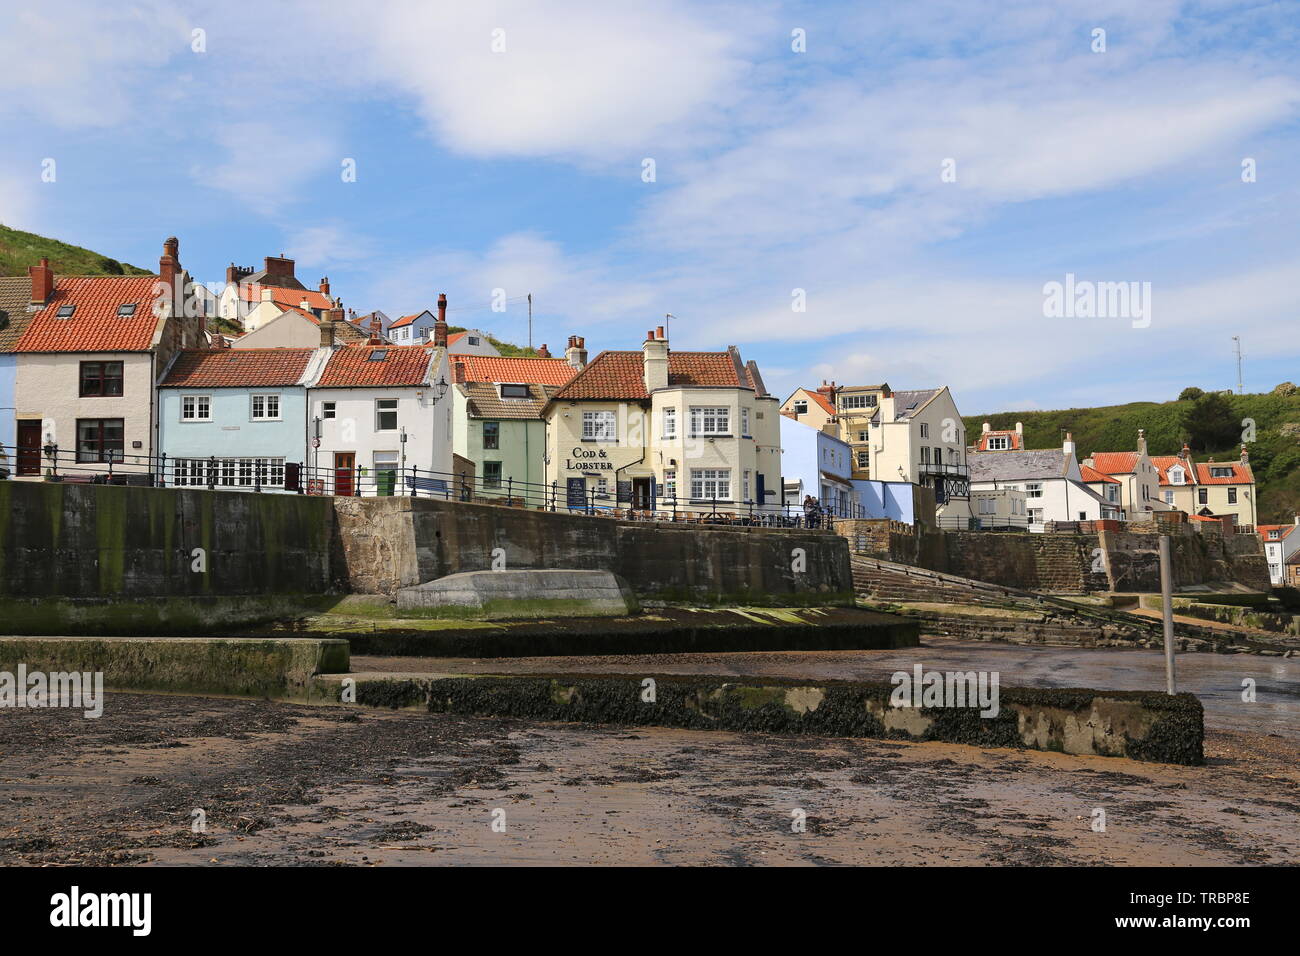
[[0, 445, 867, 528]]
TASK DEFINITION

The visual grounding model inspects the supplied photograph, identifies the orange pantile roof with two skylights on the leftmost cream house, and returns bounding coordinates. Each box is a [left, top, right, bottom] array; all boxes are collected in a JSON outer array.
[[14, 276, 159, 352]]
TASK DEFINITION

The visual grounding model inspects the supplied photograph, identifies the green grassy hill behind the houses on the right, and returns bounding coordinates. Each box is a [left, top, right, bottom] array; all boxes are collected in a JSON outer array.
[[963, 392, 1300, 524]]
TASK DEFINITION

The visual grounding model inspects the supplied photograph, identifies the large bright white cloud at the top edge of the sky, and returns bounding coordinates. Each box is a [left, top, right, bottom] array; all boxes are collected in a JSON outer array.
[[313, 0, 763, 159]]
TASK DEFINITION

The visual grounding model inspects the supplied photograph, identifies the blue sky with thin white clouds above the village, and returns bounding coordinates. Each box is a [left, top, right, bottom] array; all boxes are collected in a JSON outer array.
[[0, 0, 1300, 414]]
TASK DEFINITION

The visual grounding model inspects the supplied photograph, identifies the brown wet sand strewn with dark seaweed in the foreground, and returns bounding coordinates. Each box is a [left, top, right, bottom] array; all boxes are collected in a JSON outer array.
[[0, 686, 1300, 865]]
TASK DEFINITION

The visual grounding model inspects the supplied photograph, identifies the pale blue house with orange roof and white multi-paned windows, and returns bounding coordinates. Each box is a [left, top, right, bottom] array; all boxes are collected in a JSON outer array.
[[159, 349, 319, 489]]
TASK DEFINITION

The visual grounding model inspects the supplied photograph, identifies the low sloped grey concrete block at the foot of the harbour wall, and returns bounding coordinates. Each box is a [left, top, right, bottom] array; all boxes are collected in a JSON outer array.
[[398, 568, 640, 619]]
